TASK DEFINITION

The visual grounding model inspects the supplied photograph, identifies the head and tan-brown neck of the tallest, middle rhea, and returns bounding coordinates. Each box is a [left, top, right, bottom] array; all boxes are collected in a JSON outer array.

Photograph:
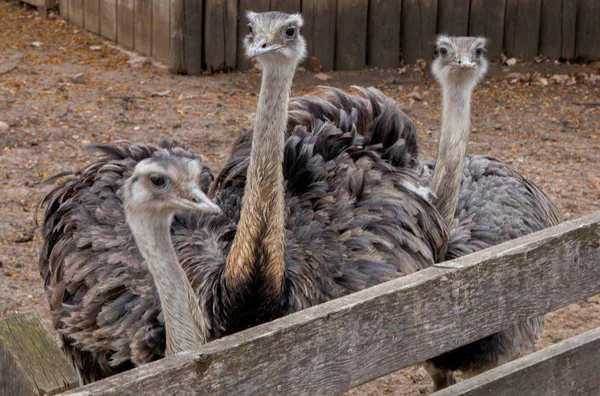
[[225, 12, 306, 296]]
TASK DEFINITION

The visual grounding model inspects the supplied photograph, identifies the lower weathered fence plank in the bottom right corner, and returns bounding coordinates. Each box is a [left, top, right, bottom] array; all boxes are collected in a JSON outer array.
[[434, 328, 600, 396]]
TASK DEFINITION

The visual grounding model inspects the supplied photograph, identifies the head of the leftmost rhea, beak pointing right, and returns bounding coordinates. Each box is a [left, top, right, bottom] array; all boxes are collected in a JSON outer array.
[[122, 149, 221, 218]]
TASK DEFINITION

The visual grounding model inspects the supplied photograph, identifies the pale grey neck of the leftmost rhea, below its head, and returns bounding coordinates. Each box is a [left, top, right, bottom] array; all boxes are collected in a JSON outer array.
[[127, 210, 210, 356]]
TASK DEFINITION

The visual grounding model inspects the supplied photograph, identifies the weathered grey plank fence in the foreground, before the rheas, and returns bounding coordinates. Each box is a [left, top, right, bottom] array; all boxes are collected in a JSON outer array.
[[0, 212, 600, 396]]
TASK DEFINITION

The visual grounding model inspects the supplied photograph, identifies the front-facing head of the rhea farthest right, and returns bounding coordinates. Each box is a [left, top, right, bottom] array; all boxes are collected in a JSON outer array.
[[431, 35, 488, 89]]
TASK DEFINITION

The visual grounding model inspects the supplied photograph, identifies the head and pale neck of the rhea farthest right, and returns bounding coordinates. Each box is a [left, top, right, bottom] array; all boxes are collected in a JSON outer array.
[[431, 36, 488, 227]]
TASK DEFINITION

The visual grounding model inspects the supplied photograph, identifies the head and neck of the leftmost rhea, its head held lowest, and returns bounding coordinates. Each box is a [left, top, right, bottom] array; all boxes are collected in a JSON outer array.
[[122, 150, 220, 356]]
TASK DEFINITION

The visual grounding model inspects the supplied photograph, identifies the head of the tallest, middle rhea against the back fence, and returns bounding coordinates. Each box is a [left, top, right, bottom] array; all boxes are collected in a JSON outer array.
[[244, 11, 306, 67]]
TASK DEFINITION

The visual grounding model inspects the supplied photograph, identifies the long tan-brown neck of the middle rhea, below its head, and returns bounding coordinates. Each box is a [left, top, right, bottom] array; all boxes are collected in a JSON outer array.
[[224, 64, 295, 296]]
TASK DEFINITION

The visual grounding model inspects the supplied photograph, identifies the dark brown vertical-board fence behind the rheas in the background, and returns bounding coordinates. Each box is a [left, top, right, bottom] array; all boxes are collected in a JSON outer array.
[[52, 0, 600, 74]]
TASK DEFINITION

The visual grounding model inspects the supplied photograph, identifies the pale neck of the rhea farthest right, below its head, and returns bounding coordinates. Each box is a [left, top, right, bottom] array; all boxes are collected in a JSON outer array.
[[431, 78, 475, 227]]
